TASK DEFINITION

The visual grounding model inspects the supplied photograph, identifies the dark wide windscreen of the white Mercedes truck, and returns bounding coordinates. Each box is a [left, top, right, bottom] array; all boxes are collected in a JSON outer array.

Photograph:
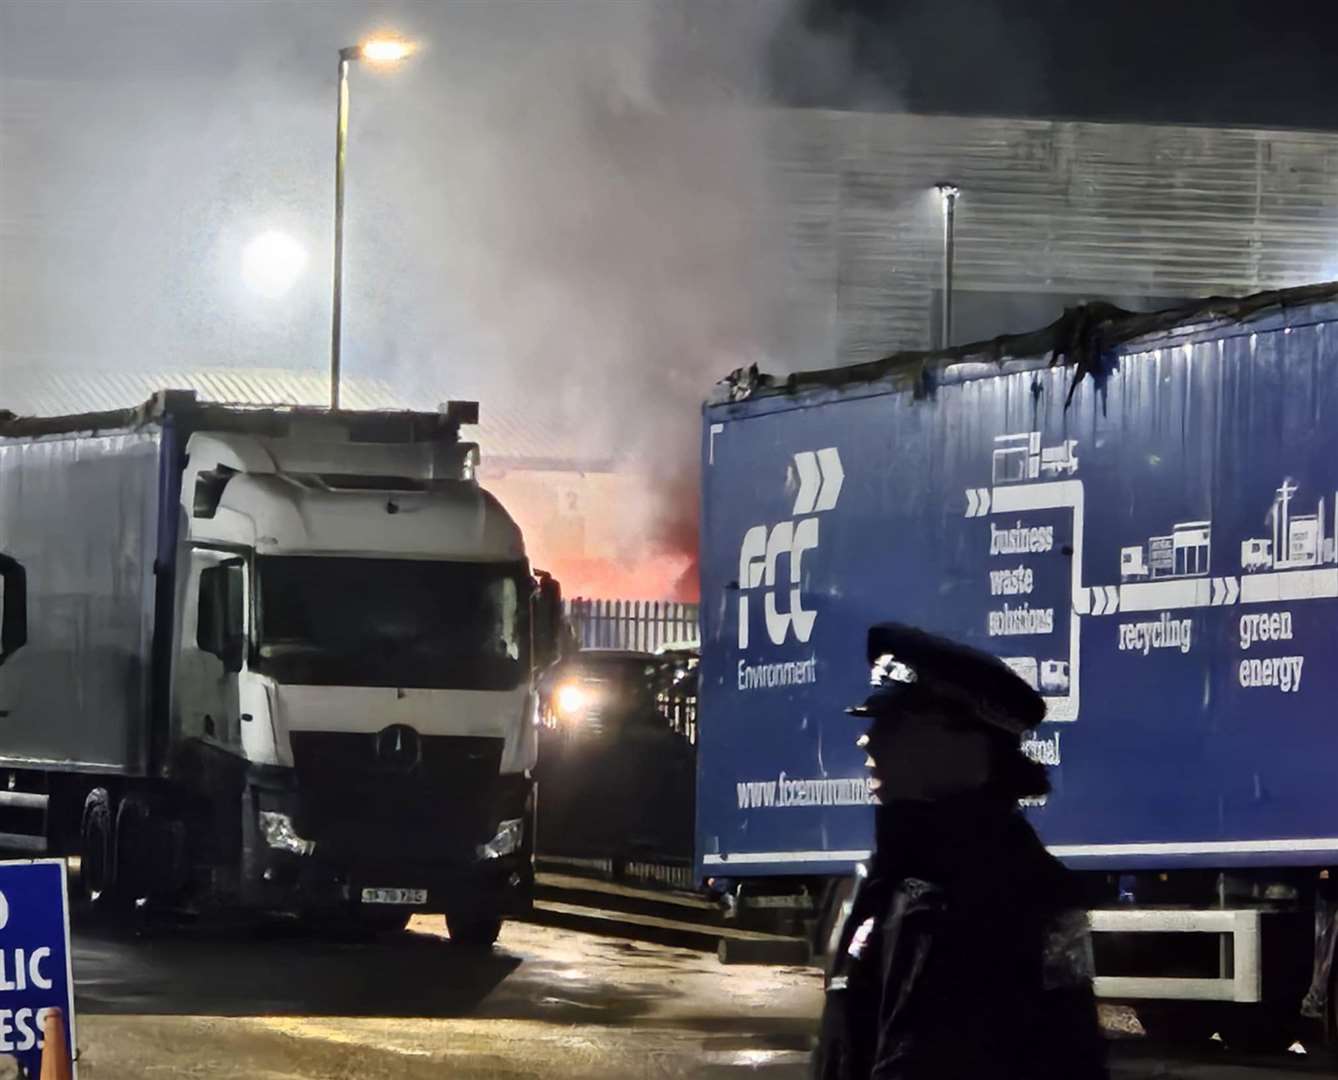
[[253, 555, 530, 691]]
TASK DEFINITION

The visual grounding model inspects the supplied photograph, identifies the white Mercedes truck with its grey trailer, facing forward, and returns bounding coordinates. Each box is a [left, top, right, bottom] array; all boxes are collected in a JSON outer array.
[[0, 391, 561, 943]]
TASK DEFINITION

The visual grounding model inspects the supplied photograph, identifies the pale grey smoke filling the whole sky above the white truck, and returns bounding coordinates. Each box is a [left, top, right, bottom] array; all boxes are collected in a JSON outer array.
[[0, 0, 844, 596]]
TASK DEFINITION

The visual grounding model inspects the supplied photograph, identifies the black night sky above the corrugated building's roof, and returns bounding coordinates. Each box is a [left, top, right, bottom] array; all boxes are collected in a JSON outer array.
[[772, 0, 1338, 128]]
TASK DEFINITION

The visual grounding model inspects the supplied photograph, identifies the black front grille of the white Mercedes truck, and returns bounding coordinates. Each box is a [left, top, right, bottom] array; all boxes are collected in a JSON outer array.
[[292, 732, 503, 862]]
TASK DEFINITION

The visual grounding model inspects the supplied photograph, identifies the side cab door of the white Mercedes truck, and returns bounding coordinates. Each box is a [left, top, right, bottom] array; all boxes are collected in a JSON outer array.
[[177, 549, 249, 749]]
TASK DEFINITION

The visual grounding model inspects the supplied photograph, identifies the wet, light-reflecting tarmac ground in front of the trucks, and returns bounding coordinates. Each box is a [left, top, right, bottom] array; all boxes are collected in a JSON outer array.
[[65, 917, 1333, 1080]]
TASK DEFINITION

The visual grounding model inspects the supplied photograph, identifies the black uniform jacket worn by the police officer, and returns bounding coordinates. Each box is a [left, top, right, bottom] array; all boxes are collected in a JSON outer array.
[[814, 799, 1107, 1080]]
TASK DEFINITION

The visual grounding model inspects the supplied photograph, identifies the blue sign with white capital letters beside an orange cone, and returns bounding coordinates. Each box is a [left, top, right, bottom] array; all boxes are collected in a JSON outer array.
[[0, 859, 75, 1076]]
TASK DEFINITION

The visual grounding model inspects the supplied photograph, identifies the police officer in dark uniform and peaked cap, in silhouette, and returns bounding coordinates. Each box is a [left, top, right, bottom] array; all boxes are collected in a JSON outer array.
[[815, 624, 1107, 1080]]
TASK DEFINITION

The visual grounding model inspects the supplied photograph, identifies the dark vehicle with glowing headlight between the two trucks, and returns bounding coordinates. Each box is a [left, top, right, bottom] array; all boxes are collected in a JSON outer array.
[[535, 649, 697, 869]]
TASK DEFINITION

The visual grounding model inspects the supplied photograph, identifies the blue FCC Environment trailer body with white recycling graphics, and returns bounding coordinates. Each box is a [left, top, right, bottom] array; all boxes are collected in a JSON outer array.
[[697, 286, 1338, 877]]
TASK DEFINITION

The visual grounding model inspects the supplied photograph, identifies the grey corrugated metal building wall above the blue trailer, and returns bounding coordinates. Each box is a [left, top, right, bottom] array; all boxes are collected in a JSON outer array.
[[768, 111, 1338, 367]]
